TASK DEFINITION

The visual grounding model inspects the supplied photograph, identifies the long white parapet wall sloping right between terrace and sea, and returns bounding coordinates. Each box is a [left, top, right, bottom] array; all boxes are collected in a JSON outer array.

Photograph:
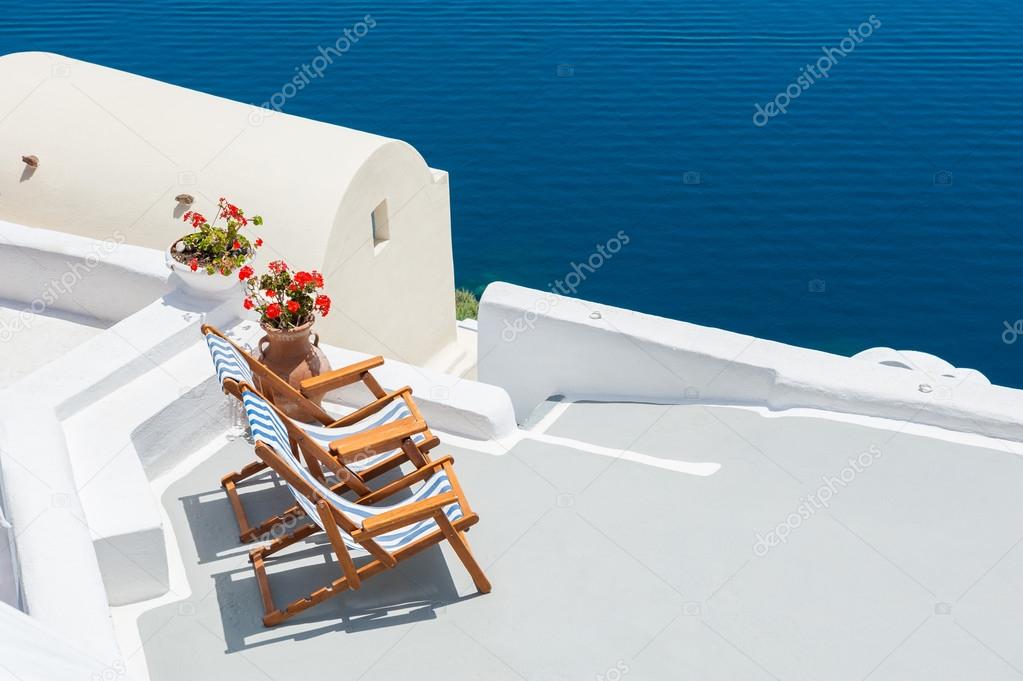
[[479, 283, 1023, 441]]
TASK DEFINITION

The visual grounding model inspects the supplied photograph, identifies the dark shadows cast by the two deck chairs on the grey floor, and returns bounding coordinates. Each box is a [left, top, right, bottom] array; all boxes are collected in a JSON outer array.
[[178, 471, 470, 652]]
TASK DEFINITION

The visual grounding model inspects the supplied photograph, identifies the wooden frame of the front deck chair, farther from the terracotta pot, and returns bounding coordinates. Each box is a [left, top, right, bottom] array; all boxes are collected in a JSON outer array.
[[242, 387, 491, 627]]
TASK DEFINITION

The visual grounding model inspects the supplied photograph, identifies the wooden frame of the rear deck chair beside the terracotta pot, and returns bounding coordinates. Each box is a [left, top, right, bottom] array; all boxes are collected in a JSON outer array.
[[199, 324, 440, 543]]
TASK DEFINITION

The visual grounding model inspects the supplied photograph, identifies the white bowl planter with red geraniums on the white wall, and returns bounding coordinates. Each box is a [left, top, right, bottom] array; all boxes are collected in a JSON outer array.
[[168, 197, 263, 294]]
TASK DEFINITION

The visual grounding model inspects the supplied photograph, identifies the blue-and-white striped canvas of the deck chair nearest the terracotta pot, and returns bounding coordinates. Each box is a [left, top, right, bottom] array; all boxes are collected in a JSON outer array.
[[206, 333, 427, 472]]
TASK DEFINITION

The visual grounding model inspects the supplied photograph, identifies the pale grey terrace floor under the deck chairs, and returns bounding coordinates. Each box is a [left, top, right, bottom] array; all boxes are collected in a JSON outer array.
[[120, 403, 1023, 681]]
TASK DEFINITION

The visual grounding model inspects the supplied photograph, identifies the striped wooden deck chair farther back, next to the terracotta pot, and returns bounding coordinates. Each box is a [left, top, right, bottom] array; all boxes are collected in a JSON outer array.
[[202, 325, 440, 542]]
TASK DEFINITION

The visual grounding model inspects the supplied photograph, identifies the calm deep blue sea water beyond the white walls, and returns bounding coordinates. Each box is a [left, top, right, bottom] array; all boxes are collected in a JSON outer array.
[[0, 0, 1023, 385]]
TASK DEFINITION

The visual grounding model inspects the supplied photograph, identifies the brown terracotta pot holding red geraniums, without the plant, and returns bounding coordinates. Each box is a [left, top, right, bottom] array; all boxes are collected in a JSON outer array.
[[259, 320, 330, 420]]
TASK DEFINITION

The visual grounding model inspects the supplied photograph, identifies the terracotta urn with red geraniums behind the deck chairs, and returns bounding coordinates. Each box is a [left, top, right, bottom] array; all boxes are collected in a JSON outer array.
[[238, 260, 330, 418]]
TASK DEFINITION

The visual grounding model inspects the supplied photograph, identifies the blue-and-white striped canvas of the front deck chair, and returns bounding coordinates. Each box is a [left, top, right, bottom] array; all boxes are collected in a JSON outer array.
[[241, 391, 463, 553]]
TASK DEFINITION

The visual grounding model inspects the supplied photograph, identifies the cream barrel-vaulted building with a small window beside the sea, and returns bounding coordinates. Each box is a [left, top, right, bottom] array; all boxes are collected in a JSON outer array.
[[0, 52, 455, 364]]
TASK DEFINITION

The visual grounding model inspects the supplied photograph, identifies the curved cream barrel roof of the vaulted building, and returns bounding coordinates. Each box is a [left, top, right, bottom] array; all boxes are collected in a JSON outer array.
[[0, 52, 429, 259]]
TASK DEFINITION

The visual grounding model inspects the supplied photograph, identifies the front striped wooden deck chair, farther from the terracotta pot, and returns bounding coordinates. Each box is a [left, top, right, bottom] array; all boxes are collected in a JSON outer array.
[[240, 384, 491, 627]]
